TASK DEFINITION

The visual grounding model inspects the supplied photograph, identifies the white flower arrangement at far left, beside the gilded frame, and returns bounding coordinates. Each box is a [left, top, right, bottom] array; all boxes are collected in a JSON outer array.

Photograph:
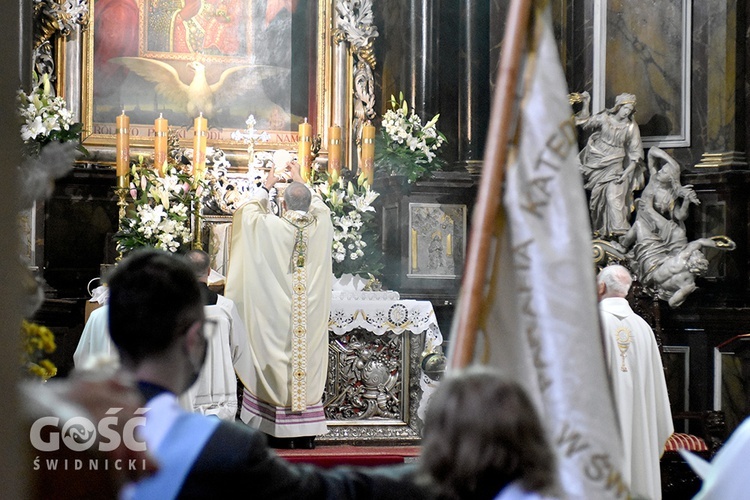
[[18, 73, 83, 154]]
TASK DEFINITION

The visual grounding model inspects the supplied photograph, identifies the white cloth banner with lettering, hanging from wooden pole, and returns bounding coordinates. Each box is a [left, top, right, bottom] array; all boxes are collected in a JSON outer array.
[[475, 4, 628, 499]]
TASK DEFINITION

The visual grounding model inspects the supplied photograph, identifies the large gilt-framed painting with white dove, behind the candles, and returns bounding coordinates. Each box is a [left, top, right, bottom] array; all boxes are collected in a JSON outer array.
[[77, 0, 333, 157]]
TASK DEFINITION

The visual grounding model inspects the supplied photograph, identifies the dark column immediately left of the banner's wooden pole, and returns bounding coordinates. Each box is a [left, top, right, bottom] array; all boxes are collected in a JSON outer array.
[[457, 0, 490, 172]]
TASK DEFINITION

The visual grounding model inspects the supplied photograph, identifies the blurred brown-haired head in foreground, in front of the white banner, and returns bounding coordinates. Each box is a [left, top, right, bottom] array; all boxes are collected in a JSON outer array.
[[417, 365, 555, 500]]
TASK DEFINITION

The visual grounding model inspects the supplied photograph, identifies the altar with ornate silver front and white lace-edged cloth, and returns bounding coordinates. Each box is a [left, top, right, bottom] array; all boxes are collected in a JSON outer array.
[[318, 291, 443, 444]]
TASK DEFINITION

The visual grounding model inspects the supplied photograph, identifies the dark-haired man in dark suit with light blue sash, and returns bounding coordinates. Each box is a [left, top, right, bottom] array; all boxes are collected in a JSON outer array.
[[109, 250, 426, 499]]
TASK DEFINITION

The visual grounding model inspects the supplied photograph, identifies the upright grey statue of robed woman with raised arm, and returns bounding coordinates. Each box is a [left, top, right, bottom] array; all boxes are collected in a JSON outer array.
[[575, 92, 645, 239]]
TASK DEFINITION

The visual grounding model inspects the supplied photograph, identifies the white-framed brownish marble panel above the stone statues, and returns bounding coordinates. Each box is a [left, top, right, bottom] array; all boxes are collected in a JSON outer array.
[[592, 0, 692, 147]]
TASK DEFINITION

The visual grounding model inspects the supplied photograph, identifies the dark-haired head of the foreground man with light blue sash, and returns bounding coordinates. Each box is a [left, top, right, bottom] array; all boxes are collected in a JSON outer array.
[[109, 250, 208, 394]]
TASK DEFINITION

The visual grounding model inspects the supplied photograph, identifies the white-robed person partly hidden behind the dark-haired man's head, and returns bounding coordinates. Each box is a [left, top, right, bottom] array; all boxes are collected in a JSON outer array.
[[180, 249, 253, 420]]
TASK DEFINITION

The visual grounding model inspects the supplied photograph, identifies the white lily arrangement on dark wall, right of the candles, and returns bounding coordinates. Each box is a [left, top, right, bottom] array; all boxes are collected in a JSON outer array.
[[375, 93, 445, 182]]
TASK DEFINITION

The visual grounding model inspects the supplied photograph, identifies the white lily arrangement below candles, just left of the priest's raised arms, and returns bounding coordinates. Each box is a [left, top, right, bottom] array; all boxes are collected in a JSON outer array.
[[114, 157, 206, 254]]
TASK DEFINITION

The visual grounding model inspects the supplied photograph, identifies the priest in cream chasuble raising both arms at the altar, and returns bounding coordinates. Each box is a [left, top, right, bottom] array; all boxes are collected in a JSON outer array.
[[225, 163, 333, 448]]
